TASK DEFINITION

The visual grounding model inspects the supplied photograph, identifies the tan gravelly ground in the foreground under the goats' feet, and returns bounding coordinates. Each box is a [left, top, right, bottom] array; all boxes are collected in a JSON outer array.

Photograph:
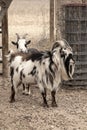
[[0, 78, 87, 130]]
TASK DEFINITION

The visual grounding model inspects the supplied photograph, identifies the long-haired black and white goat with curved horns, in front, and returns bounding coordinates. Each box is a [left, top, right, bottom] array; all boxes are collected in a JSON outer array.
[[10, 41, 75, 107]]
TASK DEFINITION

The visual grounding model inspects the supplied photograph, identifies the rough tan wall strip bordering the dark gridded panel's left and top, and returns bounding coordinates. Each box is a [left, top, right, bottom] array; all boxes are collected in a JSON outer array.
[[55, 0, 87, 39]]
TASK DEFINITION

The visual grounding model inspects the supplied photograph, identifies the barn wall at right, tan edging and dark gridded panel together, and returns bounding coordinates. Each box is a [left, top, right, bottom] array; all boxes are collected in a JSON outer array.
[[55, 0, 87, 87]]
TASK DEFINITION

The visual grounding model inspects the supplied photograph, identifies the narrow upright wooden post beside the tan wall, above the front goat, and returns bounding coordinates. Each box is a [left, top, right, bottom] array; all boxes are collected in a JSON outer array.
[[50, 0, 54, 44]]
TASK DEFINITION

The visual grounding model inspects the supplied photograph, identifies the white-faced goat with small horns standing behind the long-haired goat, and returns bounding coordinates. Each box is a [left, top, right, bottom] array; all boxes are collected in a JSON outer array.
[[11, 33, 38, 95]]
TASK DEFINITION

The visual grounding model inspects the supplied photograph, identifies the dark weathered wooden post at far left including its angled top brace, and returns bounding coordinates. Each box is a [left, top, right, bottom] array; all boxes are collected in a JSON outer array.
[[0, 0, 12, 77]]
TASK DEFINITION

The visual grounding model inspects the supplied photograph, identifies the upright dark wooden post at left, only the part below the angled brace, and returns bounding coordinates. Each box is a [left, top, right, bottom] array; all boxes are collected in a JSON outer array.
[[2, 9, 8, 77]]
